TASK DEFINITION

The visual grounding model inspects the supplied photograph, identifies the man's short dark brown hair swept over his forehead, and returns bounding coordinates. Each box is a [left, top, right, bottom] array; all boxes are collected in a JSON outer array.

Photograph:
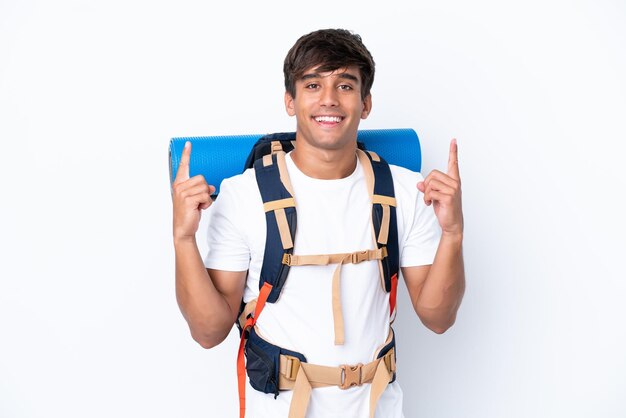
[[283, 29, 375, 99]]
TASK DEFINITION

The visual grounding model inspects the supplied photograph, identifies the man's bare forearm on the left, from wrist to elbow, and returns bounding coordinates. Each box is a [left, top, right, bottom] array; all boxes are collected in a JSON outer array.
[[174, 239, 234, 348]]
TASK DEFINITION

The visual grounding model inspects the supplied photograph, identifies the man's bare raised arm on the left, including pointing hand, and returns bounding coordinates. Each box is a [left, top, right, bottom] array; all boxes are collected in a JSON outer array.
[[172, 142, 246, 348]]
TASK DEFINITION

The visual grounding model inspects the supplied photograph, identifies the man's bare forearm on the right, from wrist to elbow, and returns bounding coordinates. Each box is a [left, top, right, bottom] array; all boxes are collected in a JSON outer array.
[[414, 233, 465, 333]]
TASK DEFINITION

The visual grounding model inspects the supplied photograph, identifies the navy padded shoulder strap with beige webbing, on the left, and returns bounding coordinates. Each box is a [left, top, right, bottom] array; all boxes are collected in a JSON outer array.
[[254, 151, 297, 303]]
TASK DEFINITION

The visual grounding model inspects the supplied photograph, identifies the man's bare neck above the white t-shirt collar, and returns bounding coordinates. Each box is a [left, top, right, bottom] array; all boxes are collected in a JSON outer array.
[[291, 141, 356, 180]]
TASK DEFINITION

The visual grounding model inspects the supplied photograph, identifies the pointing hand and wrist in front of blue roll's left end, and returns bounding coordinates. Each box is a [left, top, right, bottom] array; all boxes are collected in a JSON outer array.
[[172, 141, 215, 240]]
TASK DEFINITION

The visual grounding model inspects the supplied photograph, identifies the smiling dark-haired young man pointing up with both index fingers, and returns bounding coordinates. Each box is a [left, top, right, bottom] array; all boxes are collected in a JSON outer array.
[[173, 30, 465, 418]]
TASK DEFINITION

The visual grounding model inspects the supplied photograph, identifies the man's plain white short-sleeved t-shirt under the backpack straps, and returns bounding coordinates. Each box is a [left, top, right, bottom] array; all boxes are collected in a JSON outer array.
[[205, 155, 440, 418]]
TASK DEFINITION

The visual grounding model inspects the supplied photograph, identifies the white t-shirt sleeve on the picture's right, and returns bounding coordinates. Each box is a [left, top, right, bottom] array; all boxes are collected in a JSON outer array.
[[400, 173, 441, 267]]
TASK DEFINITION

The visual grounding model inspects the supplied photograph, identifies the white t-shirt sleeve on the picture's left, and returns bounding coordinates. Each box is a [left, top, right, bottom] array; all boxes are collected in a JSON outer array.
[[204, 179, 250, 271]]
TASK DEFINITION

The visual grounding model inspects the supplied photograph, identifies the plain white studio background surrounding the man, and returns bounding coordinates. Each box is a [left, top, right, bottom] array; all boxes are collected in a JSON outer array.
[[0, 0, 626, 418]]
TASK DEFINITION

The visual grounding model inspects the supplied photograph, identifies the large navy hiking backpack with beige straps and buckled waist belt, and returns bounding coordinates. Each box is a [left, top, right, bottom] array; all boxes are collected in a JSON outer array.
[[237, 133, 399, 418]]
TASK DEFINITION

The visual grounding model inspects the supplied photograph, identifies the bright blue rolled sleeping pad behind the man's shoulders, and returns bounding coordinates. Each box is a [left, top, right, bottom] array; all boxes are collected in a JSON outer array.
[[169, 129, 422, 194]]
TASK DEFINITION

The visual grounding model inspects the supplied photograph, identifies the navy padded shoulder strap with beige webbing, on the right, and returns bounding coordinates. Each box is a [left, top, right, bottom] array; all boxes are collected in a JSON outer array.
[[358, 151, 400, 292]]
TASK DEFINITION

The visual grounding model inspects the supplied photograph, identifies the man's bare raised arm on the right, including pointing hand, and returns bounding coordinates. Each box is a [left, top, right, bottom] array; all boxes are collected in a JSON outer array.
[[402, 139, 465, 334]]
